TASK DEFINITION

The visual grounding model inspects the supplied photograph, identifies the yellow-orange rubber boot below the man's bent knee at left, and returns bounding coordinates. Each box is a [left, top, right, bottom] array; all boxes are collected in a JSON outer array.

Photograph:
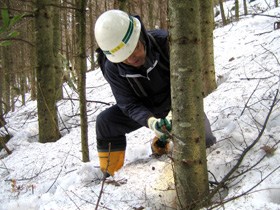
[[98, 151, 125, 176]]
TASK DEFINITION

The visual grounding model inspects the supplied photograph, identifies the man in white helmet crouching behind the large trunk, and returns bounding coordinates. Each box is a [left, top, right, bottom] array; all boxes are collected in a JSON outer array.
[[95, 10, 216, 176]]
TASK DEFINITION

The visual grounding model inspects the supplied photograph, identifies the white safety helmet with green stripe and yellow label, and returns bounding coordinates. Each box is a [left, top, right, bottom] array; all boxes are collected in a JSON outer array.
[[94, 10, 141, 63]]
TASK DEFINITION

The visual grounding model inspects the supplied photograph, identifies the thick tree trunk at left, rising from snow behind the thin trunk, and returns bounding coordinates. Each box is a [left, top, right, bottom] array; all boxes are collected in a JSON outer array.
[[35, 0, 61, 143]]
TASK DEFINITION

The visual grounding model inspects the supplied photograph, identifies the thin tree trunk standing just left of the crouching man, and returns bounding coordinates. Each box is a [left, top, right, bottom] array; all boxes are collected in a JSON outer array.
[[77, 0, 89, 162]]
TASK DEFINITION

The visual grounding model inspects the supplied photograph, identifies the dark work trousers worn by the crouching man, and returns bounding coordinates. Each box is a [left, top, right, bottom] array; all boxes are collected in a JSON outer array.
[[96, 105, 216, 152]]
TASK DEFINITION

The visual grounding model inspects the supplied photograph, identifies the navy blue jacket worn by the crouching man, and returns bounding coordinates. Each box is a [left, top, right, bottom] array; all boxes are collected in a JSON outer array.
[[105, 16, 171, 126]]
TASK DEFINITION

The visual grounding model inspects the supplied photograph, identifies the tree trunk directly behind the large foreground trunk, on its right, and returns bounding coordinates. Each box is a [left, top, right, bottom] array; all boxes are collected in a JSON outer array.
[[200, 0, 217, 97]]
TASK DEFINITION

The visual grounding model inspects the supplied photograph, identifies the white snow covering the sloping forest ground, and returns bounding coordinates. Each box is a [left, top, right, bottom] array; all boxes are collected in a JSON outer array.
[[0, 0, 280, 210]]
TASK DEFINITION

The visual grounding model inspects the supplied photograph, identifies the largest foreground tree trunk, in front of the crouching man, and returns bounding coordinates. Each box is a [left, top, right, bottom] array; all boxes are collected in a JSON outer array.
[[169, 0, 209, 209]]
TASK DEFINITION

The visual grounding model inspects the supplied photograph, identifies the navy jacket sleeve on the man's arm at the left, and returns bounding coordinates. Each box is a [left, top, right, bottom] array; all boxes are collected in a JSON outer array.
[[105, 61, 153, 127]]
